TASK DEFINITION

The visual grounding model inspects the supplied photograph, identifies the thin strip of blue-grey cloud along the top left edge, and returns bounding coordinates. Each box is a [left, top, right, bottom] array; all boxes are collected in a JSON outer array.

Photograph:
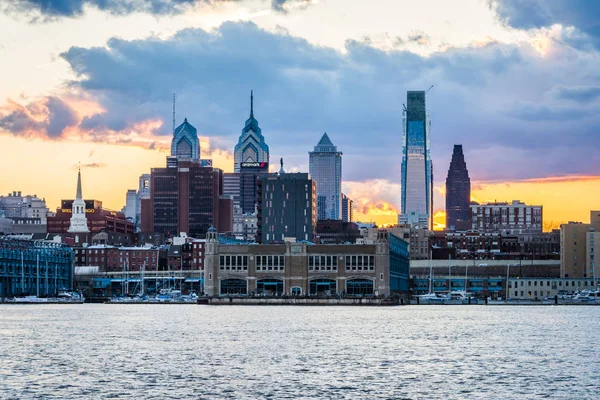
[[0, 0, 311, 21]]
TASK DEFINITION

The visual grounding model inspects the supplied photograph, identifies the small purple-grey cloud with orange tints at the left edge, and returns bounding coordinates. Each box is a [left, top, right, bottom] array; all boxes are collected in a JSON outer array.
[[0, 96, 78, 138]]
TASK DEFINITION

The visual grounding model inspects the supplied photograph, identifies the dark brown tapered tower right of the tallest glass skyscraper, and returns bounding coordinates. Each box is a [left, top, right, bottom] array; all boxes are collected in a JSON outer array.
[[446, 144, 471, 231]]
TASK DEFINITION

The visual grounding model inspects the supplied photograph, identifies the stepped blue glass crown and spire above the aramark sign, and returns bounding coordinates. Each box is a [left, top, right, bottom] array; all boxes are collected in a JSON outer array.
[[233, 91, 269, 172]]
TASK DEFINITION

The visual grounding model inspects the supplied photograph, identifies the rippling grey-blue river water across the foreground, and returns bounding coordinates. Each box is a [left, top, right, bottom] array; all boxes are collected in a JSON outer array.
[[0, 304, 600, 399]]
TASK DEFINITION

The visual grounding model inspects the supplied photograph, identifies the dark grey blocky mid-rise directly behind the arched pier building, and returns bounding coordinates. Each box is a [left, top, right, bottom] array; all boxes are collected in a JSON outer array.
[[256, 173, 317, 243]]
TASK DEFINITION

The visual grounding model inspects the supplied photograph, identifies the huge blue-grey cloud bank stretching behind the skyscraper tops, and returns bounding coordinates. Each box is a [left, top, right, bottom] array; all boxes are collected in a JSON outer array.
[[0, 22, 600, 182]]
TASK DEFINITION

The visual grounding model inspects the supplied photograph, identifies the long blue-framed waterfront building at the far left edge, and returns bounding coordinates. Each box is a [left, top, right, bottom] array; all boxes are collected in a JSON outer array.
[[0, 237, 73, 299]]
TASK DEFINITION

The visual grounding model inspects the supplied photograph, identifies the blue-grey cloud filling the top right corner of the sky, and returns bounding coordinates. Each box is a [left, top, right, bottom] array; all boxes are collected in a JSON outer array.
[[488, 0, 600, 45]]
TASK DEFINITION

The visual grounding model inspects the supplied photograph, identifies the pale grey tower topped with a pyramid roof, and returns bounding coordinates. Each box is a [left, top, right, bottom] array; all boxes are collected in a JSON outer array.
[[308, 133, 342, 220]]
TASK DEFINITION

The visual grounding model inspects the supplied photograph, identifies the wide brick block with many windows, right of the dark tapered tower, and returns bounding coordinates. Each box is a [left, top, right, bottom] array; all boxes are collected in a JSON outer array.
[[471, 200, 544, 235]]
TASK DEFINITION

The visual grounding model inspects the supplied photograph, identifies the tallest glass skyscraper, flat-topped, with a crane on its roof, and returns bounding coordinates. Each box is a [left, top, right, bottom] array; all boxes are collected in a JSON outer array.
[[399, 90, 433, 229]]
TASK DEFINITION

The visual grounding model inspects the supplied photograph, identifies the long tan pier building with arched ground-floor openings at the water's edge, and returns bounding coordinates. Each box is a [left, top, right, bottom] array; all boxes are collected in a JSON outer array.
[[204, 230, 408, 297]]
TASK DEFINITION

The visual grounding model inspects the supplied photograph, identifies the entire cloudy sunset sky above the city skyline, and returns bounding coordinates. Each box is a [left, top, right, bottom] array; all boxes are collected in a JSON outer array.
[[0, 0, 600, 228]]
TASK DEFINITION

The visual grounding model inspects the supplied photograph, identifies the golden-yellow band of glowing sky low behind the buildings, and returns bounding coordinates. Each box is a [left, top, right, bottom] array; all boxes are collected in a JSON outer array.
[[0, 133, 600, 225]]
